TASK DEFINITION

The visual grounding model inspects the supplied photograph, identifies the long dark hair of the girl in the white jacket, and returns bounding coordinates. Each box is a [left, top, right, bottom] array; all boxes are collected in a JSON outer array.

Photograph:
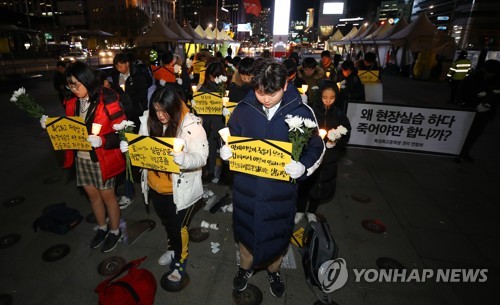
[[148, 83, 184, 137]]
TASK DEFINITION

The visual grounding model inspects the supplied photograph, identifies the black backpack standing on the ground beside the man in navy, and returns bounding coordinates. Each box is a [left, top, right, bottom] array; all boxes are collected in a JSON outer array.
[[299, 221, 338, 304]]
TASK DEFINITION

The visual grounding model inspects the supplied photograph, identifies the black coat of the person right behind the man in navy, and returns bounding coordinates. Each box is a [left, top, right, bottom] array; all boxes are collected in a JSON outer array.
[[300, 101, 351, 202]]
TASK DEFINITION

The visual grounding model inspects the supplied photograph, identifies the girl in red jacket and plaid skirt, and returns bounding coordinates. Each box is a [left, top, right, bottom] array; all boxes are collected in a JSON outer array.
[[41, 61, 126, 252]]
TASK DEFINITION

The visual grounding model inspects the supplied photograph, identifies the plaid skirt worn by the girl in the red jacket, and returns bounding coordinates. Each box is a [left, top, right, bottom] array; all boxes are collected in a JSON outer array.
[[76, 158, 116, 190]]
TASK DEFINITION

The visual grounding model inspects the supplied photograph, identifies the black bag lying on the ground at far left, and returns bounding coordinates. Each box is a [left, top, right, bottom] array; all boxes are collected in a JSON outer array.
[[33, 202, 83, 235]]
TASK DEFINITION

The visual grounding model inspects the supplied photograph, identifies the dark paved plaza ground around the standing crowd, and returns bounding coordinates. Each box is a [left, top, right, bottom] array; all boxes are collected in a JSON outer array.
[[0, 70, 500, 305]]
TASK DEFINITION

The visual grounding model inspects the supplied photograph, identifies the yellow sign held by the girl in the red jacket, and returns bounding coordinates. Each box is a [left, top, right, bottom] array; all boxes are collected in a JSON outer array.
[[46, 116, 92, 150]]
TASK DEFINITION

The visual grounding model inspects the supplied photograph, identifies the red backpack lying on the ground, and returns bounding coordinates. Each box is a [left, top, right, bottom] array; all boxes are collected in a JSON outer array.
[[95, 256, 157, 305]]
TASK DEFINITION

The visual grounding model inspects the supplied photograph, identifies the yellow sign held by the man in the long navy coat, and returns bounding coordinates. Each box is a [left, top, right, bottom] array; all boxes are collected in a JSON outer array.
[[228, 136, 292, 181]]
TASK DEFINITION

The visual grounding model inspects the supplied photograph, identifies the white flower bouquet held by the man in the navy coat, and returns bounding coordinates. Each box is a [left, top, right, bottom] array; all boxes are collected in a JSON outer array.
[[285, 114, 317, 183]]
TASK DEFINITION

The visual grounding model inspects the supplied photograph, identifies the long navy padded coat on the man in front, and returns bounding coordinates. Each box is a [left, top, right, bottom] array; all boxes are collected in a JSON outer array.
[[228, 87, 324, 266]]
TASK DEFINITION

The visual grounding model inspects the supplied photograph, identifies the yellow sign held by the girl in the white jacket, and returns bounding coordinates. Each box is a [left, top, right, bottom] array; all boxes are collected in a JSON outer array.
[[125, 133, 179, 173]]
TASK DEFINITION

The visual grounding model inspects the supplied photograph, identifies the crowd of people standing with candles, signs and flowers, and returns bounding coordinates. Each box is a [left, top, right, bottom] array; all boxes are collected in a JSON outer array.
[[41, 45, 500, 297]]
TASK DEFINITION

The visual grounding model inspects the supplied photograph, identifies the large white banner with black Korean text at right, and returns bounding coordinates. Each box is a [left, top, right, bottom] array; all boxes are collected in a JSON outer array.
[[347, 102, 475, 155]]
